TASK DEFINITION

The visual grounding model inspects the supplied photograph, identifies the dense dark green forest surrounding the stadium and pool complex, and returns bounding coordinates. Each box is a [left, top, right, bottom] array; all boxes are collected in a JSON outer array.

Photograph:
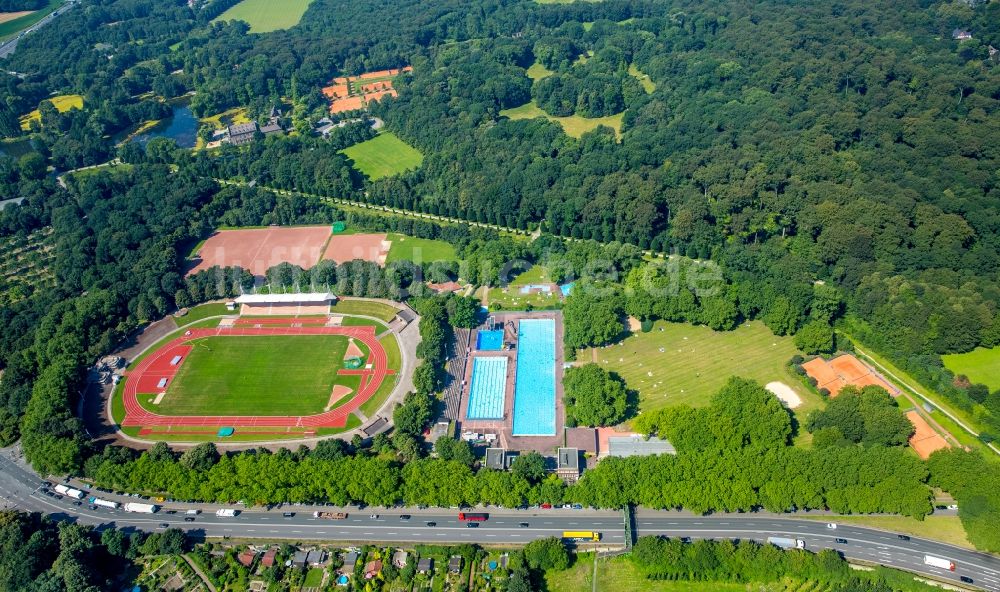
[[0, 0, 1000, 560]]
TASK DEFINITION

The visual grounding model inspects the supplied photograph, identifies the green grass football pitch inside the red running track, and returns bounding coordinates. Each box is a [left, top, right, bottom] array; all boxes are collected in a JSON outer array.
[[152, 335, 356, 415]]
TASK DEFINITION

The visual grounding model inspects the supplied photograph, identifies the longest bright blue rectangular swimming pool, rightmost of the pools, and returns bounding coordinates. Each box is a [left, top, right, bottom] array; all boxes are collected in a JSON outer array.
[[512, 319, 556, 436]]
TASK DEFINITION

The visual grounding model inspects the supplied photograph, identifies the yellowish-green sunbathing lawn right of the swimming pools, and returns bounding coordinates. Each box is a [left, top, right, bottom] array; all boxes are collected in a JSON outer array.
[[577, 321, 821, 418]]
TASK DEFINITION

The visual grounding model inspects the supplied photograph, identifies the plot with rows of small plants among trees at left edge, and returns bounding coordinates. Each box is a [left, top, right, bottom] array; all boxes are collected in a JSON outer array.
[[0, 228, 55, 306]]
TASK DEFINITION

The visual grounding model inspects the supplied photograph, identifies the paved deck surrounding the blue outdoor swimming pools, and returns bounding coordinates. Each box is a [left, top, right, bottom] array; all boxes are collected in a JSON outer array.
[[459, 311, 566, 453]]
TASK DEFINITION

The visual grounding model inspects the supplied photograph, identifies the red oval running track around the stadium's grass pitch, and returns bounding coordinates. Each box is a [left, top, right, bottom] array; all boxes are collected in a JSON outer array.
[[122, 319, 394, 428]]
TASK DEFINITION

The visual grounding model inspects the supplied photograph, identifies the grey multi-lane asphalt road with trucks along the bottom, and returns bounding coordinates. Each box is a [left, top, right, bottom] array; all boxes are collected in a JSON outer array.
[[0, 449, 1000, 592]]
